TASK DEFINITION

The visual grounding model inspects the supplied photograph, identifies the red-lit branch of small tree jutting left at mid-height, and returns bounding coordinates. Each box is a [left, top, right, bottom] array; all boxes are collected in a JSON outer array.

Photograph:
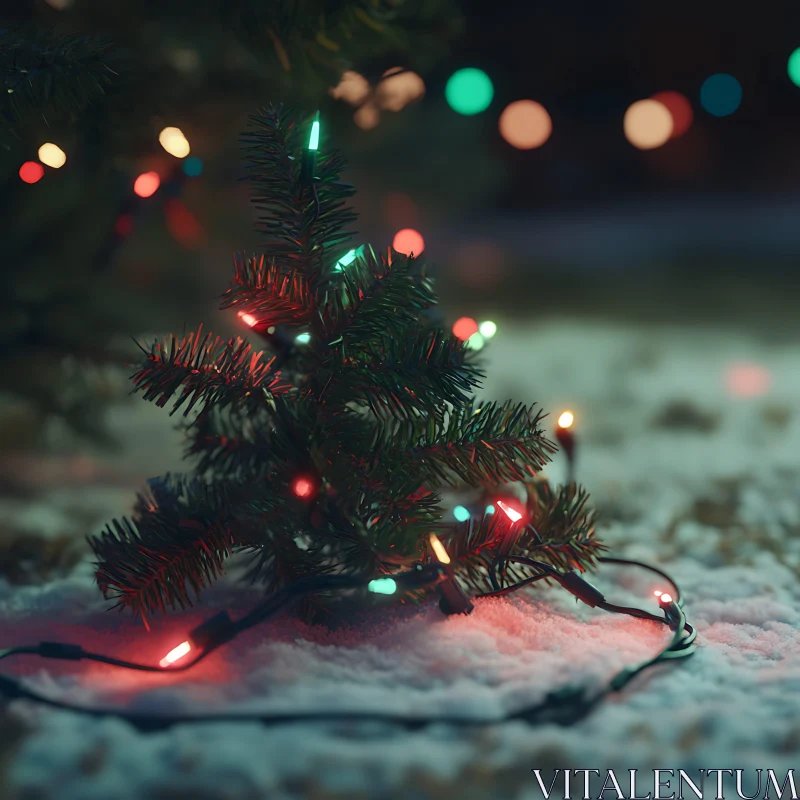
[[132, 325, 291, 415]]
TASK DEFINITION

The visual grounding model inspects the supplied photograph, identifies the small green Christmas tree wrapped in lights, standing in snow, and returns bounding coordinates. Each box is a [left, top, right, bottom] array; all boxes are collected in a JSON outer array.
[[91, 107, 602, 621]]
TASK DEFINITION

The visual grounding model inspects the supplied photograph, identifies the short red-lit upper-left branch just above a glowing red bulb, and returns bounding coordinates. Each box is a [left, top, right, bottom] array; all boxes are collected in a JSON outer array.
[[220, 253, 314, 327]]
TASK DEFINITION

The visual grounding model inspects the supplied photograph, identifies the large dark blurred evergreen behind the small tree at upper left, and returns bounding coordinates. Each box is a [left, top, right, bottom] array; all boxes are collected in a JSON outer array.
[[0, 0, 461, 447]]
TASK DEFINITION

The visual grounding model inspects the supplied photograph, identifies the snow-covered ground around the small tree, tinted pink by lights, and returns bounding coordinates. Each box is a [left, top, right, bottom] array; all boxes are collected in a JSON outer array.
[[0, 321, 800, 800]]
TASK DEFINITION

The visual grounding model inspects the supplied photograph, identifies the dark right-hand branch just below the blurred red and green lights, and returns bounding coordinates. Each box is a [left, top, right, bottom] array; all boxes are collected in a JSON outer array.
[[319, 327, 484, 419]]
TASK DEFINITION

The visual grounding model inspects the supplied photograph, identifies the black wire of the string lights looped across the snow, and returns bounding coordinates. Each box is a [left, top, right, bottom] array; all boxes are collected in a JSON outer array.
[[0, 556, 696, 731]]
